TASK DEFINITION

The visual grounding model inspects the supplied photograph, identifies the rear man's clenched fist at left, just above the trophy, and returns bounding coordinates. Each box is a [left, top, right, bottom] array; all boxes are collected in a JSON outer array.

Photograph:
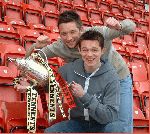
[[35, 35, 50, 49]]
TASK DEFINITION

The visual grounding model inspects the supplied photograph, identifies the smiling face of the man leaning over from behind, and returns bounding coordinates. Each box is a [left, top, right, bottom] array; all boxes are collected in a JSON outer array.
[[59, 22, 82, 48]]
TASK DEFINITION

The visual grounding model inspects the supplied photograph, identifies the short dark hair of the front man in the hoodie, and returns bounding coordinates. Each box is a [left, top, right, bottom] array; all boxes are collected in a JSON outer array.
[[77, 30, 104, 49]]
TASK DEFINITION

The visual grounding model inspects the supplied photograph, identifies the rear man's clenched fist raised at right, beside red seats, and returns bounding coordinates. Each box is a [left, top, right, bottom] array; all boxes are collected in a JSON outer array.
[[105, 17, 122, 30]]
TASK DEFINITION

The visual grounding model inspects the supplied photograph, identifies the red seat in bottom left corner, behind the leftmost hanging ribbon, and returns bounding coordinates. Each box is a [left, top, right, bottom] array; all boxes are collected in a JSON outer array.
[[2, 101, 48, 133]]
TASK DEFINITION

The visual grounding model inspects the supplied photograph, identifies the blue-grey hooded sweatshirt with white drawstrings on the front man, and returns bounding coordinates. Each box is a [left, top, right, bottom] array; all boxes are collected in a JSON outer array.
[[59, 59, 120, 124]]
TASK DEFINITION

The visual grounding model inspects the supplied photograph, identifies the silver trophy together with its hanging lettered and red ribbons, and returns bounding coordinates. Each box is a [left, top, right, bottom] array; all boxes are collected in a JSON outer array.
[[9, 50, 76, 133]]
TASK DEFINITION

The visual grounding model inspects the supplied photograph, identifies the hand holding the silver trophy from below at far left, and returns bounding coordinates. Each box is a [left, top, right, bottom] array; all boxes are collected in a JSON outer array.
[[14, 78, 30, 93]]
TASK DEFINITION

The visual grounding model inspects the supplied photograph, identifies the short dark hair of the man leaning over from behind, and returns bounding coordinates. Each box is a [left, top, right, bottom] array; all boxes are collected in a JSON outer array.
[[57, 10, 82, 29]]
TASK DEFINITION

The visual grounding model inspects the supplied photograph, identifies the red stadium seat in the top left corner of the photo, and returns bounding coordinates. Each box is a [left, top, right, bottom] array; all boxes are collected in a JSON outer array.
[[2, 0, 23, 19]]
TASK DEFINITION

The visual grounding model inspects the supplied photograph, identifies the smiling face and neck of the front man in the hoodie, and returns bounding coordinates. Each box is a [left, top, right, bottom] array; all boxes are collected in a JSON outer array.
[[79, 40, 104, 72]]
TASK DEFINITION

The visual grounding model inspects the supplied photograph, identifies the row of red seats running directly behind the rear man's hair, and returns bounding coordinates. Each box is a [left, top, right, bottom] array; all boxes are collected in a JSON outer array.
[[1, 1, 149, 26]]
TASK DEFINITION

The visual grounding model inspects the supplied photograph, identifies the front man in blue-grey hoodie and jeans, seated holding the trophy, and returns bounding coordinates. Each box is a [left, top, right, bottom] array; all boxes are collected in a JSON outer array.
[[45, 30, 120, 133]]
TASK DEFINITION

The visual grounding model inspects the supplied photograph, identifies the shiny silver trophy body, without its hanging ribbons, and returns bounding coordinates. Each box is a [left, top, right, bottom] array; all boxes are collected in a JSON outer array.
[[8, 51, 49, 86]]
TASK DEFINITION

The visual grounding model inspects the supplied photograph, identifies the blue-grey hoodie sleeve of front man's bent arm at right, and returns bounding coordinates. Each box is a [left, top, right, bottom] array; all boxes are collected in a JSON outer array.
[[80, 80, 120, 124]]
